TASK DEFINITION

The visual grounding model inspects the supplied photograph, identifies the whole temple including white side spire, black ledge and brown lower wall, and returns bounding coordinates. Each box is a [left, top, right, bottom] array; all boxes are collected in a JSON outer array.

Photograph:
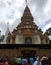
[[0, 1, 51, 59]]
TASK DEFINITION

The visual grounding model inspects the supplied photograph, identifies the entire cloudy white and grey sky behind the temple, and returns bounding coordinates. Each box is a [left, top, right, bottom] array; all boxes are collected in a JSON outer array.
[[0, 0, 51, 34]]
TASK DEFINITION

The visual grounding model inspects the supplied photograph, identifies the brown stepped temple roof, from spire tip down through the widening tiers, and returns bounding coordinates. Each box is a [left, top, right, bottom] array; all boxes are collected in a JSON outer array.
[[13, 5, 43, 33]]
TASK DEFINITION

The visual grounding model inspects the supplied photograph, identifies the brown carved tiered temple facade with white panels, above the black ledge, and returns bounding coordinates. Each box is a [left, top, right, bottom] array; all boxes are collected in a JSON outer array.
[[6, 6, 49, 44]]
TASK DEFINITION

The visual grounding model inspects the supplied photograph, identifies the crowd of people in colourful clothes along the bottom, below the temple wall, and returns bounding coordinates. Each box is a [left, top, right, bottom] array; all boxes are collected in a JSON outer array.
[[0, 56, 51, 65]]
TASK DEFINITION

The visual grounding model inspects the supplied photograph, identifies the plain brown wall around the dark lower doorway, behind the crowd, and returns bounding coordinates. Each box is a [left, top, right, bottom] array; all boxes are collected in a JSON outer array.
[[0, 48, 51, 60]]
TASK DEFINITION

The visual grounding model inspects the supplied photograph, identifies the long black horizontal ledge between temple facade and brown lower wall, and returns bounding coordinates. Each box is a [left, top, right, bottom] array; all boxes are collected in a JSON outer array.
[[0, 44, 51, 49]]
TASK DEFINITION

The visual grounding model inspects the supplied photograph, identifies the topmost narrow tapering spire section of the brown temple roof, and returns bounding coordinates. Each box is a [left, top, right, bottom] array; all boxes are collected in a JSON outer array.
[[21, 6, 33, 22]]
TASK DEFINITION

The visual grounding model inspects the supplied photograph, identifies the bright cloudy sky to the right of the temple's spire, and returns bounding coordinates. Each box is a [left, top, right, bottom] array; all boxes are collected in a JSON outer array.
[[29, 0, 51, 31]]
